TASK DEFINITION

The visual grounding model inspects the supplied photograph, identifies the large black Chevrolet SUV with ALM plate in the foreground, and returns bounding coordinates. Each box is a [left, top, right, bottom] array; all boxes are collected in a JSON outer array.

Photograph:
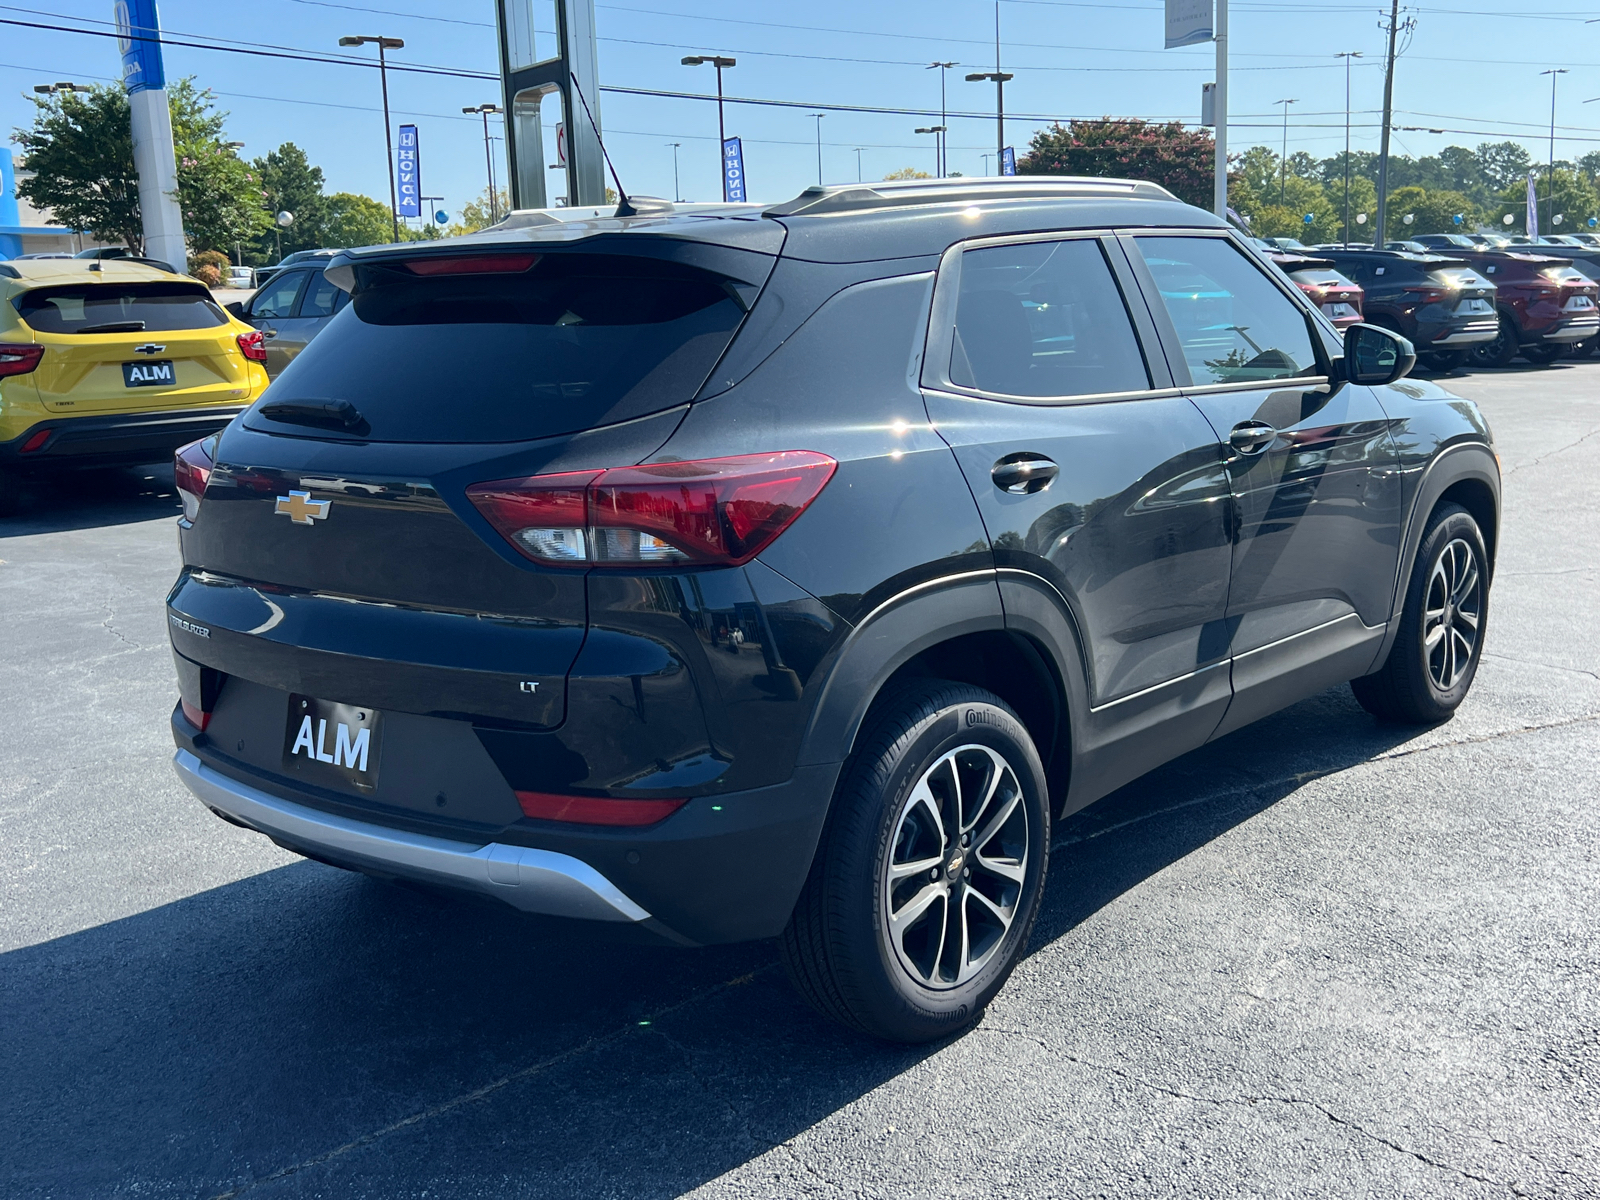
[[168, 179, 1499, 1040]]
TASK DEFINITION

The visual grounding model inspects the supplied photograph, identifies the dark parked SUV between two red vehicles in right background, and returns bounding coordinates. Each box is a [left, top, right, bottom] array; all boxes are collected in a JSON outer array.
[[1317, 248, 1499, 371]]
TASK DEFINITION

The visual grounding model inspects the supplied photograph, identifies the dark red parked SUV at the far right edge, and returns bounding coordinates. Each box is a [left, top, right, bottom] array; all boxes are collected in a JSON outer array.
[[1450, 248, 1600, 366]]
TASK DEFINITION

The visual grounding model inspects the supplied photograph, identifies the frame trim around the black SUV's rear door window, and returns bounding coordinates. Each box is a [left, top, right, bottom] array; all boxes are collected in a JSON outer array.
[[920, 229, 1179, 408]]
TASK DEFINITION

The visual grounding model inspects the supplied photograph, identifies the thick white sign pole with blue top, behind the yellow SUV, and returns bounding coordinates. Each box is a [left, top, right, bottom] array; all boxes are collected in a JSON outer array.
[[112, 0, 189, 270]]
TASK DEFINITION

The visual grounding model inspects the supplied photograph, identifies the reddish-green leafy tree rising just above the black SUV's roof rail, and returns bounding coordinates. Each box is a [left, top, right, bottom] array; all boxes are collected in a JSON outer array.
[[1016, 117, 1216, 208]]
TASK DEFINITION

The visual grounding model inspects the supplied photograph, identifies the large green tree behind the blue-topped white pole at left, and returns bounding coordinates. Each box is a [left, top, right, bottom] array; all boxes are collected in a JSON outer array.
[[13, 78, 261, 253]]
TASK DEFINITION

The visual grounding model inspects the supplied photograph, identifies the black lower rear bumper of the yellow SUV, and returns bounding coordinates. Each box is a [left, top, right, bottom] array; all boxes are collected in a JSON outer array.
[[0, 403, 250, 470]]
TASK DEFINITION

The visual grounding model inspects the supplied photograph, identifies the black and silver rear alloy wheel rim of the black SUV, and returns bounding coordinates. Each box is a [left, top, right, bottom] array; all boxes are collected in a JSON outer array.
[[883, 744, 1032, 990]]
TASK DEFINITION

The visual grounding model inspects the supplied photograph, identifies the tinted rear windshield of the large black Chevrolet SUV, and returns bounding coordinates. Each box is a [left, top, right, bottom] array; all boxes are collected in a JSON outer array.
[[250, 253, 744, 442]]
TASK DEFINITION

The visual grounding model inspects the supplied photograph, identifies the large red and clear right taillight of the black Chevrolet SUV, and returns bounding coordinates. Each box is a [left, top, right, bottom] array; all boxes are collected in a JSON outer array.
[[467, 450, 838, 566]]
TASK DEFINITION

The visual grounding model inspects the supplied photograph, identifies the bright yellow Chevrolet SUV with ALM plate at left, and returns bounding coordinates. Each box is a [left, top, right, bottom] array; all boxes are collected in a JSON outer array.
[[0, 259, 267, 514]]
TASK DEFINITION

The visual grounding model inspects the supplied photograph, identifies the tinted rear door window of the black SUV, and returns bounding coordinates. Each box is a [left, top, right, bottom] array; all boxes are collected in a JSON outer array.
[[950, 238, 1150, 397]]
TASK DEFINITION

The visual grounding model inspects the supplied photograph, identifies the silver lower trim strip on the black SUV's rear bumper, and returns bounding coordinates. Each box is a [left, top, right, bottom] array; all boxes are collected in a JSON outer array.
[[173, 750, 650, 922]]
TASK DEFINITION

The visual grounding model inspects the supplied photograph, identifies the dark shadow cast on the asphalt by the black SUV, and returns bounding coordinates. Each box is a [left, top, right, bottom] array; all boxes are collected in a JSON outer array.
[[0, 690, 1440, 1197]]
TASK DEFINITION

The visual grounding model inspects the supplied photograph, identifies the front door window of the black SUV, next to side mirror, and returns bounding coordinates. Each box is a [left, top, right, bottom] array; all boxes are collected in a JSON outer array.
[[1134, 237, 1318, 387]]
